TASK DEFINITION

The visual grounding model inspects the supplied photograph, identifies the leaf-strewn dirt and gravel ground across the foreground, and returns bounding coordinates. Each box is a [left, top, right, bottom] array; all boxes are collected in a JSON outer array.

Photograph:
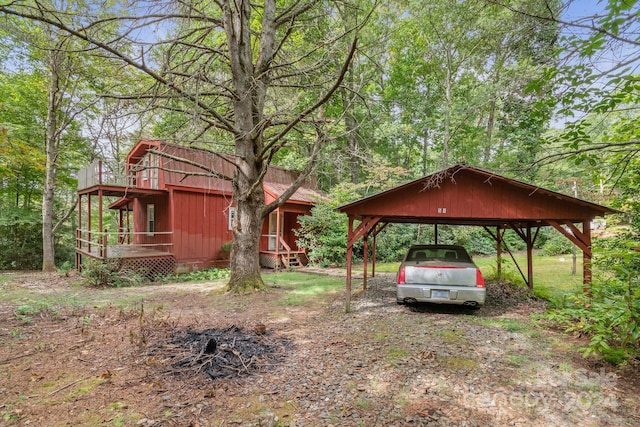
[[0, 273, 640, 426]]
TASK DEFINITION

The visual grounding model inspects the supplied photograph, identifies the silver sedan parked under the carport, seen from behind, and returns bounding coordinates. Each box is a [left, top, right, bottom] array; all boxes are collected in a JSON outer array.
[[396, 245, 487, 308]]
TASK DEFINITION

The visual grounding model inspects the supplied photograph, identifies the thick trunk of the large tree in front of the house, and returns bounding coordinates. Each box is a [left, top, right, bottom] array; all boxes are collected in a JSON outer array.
[[223, 0, 276, 293]]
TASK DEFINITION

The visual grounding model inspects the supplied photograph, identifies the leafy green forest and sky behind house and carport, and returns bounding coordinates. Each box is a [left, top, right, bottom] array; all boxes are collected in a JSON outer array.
[[0, 0, 640, 362]]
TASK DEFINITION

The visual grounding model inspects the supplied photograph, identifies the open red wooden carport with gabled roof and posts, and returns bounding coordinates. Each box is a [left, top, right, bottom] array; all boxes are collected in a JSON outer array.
[[338, 164, 617, 312]]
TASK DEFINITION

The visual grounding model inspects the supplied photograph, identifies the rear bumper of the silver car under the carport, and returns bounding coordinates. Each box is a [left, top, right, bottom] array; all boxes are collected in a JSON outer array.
[[396, 285, 487, 306]]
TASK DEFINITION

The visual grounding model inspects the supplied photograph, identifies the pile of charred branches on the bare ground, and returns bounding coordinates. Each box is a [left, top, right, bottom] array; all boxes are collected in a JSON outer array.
[[153, 325, 291, 379]]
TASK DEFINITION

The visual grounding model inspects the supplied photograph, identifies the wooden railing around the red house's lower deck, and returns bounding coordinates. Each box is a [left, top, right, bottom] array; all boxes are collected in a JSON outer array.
[[76, 229, 173, 259]]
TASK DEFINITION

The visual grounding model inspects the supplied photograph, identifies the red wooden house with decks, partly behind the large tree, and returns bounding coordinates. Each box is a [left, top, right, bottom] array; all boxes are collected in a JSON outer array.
[[76, 141, 321, 275]]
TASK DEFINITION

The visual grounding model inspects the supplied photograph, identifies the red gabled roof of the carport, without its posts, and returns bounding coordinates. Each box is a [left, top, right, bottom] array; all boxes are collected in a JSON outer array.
[[337, 164, 619, 227]]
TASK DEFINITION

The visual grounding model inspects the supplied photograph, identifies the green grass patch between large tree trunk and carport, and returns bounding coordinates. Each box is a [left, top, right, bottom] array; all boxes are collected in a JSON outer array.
[[263, 272, 345, 306]]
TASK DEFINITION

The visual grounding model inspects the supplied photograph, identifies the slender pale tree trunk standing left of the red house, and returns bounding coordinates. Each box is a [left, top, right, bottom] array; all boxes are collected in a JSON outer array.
[[42, 50, 61, 272]]
